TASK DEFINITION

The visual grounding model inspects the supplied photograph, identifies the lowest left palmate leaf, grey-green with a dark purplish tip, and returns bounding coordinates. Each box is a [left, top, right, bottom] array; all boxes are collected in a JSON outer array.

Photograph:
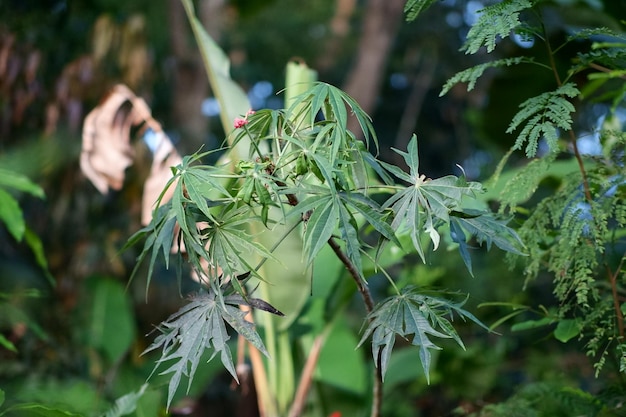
[[144, 292, 267, 408]]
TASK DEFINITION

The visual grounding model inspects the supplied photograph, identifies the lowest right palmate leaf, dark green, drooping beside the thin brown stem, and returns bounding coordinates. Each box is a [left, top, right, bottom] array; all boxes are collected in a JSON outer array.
[[359, 287, 488, 382]]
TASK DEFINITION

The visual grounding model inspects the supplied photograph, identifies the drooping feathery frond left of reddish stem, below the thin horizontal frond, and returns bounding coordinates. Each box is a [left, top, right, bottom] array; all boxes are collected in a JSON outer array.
[[506, 83, 580, 158]]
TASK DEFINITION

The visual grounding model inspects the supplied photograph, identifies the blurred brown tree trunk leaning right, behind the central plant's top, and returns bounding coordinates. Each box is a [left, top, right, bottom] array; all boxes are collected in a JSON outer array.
[[344, 0, 405, 137]]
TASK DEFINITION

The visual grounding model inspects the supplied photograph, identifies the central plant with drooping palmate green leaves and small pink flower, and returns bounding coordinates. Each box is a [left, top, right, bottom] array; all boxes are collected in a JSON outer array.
[[119, 2, 524, 416]]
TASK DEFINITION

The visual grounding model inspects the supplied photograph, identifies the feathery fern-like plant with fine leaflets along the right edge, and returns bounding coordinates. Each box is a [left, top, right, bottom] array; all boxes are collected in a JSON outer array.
[[409, 0, 626, 386]]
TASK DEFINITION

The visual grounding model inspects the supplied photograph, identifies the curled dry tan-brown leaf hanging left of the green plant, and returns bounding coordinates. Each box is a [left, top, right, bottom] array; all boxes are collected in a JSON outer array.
[[80, 84, 181, 224]]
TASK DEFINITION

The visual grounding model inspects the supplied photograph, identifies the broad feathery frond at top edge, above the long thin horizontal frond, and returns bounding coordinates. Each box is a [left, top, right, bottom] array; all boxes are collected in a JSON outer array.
[[461, 0, 532, 54]]
